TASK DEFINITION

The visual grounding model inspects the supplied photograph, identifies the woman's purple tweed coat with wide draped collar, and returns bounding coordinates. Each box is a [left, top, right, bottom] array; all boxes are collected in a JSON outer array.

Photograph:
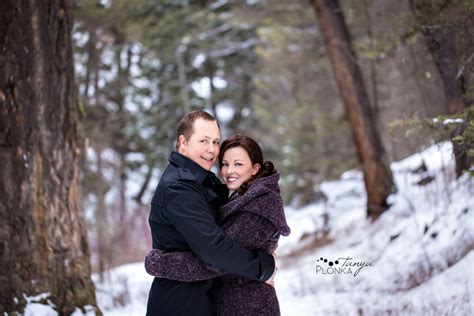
[[145, 172, 290, 315]]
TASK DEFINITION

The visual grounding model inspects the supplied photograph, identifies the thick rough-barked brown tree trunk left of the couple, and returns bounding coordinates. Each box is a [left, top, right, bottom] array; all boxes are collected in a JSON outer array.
[[0, 0, 100, 315]]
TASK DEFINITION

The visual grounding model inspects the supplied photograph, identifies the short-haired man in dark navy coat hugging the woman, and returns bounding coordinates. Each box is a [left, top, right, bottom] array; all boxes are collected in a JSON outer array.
[[147, 111, 275, 316]]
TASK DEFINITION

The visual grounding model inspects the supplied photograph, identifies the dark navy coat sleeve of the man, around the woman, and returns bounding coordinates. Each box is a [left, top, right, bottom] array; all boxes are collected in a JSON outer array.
[[165, 180, 275, 281]]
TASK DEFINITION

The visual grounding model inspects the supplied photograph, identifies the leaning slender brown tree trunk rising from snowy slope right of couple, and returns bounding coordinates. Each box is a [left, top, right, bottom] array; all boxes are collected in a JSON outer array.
[[311, 0, 395, 219]]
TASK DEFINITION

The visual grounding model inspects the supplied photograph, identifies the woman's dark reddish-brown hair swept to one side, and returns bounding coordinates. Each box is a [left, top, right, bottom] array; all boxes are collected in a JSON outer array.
[[219, 134, 276, 194]]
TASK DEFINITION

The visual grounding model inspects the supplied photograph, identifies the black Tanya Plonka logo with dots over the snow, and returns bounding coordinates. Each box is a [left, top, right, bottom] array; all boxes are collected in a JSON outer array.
[[316, 256, 373, 276]]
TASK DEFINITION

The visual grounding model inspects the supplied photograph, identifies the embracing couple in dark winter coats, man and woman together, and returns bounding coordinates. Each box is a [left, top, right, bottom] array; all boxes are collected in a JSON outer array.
[[145, 111, 290, 316]]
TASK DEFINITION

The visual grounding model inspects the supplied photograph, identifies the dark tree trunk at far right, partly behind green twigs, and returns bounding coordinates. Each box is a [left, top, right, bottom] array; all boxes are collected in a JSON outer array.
[[410, 0, 470, 177]]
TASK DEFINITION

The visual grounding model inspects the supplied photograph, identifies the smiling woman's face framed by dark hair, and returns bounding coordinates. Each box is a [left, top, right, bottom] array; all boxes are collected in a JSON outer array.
[[221, 147, 260, 190]]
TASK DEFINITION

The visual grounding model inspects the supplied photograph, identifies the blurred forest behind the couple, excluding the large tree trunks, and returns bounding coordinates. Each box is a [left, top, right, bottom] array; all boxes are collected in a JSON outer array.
[[74, 0, 474, 270]]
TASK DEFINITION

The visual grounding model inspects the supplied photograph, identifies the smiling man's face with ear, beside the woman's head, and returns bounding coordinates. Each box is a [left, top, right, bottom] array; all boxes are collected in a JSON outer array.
[[178, 118, 221, 171]]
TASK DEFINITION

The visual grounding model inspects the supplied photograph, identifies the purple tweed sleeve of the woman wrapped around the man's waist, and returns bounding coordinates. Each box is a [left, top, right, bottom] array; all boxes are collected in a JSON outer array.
[[145, 249, 224, 282]]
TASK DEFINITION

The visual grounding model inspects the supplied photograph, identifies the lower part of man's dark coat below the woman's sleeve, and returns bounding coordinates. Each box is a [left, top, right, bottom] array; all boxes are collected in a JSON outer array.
[[146, 278, 215, 316]]
